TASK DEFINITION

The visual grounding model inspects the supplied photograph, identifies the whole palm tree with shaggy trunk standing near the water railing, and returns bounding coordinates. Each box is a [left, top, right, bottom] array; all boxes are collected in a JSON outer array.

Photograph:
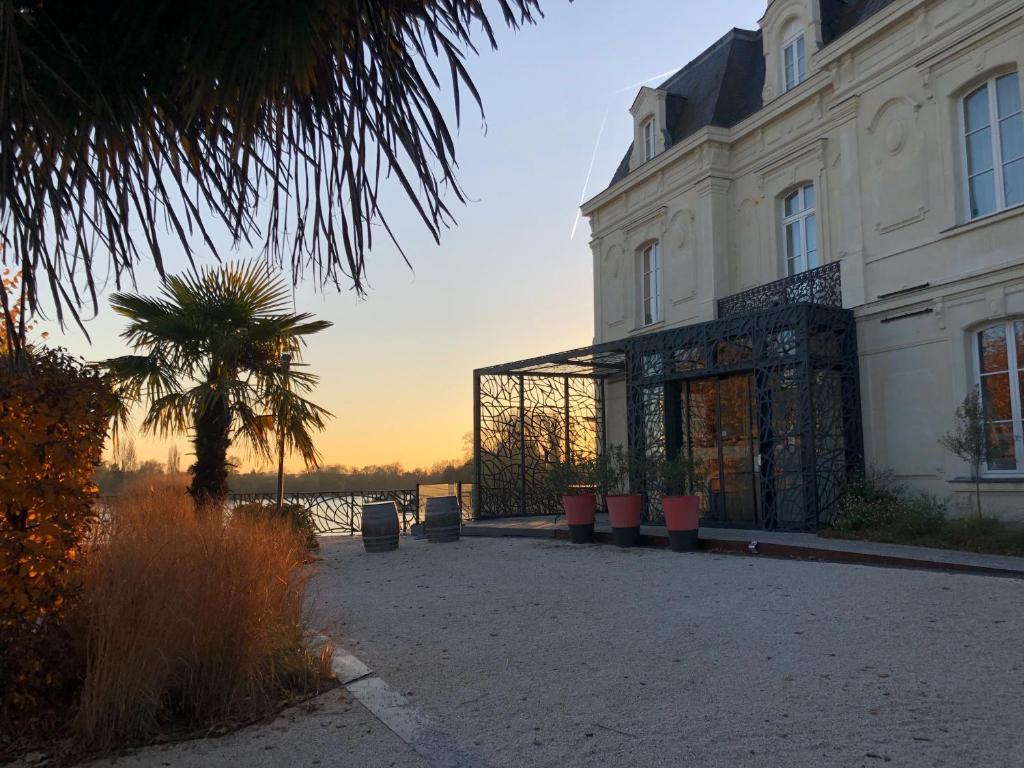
[[103, 262, 331, 508]]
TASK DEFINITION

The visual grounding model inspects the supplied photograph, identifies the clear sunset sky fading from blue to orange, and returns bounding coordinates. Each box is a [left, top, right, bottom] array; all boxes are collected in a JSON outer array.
[[51, 0, 766, 469]]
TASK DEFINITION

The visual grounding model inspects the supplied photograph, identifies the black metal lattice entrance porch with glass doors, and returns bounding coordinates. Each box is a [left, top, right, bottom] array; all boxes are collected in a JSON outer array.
[[474, 274, 863, 530]]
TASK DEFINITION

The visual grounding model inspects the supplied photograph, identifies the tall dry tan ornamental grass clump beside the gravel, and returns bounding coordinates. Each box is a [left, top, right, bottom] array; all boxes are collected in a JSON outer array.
[[76, 481, 317, 749]]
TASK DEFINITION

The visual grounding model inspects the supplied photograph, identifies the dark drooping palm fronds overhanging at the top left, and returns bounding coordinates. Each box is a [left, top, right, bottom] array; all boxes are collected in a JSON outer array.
[[0, 0, 541, 342]]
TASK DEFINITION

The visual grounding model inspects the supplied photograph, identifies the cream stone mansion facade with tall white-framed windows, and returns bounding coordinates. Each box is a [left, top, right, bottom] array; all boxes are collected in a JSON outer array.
[[583, 0, 1024, 519]]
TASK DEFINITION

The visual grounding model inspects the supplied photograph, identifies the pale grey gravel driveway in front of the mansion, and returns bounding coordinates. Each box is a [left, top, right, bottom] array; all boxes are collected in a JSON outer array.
[[311, 538, 1024, 768]]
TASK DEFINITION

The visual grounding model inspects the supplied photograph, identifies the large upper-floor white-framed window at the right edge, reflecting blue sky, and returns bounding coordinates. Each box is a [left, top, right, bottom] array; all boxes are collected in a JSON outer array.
[[964, 72, 1024, 218]]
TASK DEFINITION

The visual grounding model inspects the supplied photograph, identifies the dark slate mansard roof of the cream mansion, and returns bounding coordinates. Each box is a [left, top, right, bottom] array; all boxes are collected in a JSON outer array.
[[609, 0, 893, 186]]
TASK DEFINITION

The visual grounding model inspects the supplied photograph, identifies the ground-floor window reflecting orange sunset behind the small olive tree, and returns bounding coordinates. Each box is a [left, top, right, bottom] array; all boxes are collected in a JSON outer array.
[[978, 321, 1024, 472]]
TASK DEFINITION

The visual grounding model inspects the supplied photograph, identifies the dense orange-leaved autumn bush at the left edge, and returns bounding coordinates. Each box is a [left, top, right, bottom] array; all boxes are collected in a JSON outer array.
[[0, 349, 111, 723]]
